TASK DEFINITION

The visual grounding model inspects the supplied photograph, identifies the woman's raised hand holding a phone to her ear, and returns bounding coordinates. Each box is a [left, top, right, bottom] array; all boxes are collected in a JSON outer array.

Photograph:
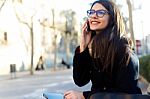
[[80, 20, 91, 52]]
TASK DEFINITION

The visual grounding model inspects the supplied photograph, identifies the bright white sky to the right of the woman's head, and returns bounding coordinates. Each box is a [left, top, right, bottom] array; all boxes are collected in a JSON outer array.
[[117, 0, 150, 39]]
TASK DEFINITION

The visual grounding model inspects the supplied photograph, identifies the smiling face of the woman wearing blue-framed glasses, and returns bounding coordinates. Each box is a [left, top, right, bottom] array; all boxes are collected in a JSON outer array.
[[89, 3, 109, 31]]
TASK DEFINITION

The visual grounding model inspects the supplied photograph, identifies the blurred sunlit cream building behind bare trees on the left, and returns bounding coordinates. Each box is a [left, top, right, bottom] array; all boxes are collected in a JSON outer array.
[[0, 0, 80, 75]]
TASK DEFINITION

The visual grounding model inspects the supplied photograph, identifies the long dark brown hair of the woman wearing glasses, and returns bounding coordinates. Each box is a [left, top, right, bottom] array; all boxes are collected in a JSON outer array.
[[91, 0, 129, 73]]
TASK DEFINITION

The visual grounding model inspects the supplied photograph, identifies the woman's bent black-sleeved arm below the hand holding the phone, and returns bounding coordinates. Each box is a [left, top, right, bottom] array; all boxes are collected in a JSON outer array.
[[73, 47, 92, 87]]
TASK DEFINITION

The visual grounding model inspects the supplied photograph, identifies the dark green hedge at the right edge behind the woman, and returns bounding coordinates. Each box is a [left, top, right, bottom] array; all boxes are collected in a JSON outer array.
[[139, 55, 150, 82]]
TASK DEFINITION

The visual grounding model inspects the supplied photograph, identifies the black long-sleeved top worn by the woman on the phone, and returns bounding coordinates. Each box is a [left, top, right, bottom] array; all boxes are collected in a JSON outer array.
[[73, 47, 141, 99]]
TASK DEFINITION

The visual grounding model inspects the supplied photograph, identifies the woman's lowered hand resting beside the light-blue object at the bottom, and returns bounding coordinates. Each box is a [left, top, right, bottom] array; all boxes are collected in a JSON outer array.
[[64, 90, 85, 99]]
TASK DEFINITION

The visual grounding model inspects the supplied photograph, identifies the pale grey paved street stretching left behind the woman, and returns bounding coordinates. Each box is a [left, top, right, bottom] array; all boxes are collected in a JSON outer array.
[[0, 69, 90, 99]]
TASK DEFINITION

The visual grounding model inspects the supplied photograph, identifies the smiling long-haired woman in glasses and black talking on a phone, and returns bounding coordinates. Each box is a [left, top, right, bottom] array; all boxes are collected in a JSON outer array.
[[64, 0, 141, 99]]
